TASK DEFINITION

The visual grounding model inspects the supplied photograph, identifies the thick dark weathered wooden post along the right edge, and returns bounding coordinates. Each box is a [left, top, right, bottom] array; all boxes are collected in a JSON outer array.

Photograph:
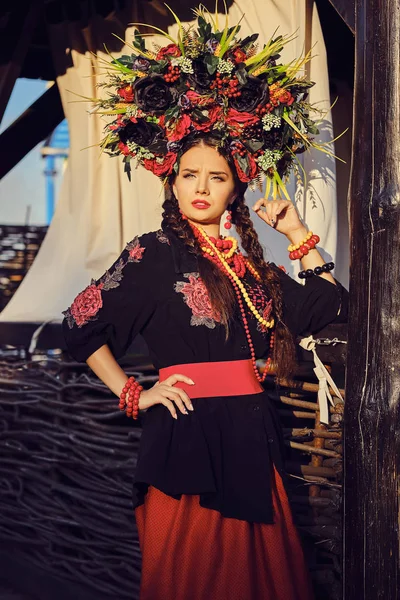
[[344, 0, 400, 600]]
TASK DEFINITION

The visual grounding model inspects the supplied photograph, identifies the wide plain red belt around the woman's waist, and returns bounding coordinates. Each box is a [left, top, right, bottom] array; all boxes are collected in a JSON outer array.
[[160, 360, 263, 398]]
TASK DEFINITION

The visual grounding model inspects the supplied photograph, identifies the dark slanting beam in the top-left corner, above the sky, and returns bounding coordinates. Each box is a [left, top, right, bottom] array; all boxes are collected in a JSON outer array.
[[0, 0, 42, 122]]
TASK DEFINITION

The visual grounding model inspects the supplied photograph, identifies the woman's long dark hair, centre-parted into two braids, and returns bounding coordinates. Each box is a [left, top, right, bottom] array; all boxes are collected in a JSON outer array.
[[162, 135, 296, 378]]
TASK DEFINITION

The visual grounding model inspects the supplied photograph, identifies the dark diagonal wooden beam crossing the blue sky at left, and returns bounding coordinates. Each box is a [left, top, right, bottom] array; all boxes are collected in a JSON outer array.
[[0, 84, 64, 179]]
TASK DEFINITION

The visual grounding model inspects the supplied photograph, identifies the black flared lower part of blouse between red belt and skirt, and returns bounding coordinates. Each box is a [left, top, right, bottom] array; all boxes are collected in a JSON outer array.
[[133, 391, 286, 523]]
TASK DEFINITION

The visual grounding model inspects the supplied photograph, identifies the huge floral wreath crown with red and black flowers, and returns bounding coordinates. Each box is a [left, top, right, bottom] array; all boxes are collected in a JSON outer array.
[[94, 2, 336, 198]]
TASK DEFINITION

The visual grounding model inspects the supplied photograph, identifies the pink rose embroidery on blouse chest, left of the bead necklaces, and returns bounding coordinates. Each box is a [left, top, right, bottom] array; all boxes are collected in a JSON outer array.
[[175, 273, 219, 329]]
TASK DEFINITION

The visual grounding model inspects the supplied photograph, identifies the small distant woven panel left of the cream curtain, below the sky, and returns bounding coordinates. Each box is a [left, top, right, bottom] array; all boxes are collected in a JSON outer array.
[[0, 225, 48, 312]]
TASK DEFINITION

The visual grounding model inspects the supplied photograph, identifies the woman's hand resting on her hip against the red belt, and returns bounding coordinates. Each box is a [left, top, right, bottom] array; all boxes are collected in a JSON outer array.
[[139, 374, 194, 419]]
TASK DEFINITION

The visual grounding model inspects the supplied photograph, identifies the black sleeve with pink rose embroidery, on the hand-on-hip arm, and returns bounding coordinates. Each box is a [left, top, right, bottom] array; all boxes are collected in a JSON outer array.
[[62, 234, 155, 362]]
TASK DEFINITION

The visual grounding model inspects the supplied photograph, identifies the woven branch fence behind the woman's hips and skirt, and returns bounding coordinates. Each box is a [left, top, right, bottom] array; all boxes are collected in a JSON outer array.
[[0, 355, 342, 600]]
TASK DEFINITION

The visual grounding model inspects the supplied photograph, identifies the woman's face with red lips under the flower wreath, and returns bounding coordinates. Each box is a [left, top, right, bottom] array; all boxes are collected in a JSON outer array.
[[172, 146, 235, 225]]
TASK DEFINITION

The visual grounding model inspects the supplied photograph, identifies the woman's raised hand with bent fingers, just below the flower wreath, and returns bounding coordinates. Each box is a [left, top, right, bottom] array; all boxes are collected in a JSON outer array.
[[253, 198, 304, 236]]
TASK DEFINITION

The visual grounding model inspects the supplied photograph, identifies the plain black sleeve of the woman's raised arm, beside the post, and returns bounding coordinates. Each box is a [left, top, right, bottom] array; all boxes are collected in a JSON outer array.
[[270, 263, 348, 336]]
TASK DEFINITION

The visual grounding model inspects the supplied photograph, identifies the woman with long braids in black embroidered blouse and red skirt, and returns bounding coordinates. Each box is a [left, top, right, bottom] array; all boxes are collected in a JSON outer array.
[[63, 135, 344, 600]]
